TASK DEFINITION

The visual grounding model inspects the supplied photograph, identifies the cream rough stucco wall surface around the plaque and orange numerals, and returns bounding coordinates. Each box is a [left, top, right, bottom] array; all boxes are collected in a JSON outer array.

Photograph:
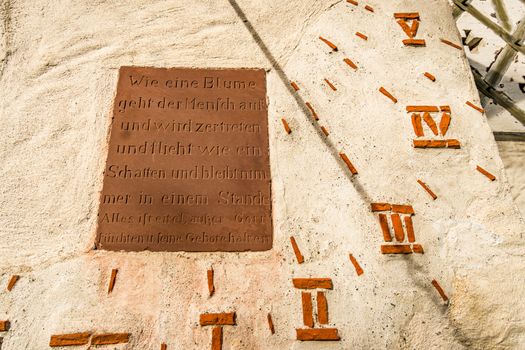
[[0, 0, 525, 350]]
